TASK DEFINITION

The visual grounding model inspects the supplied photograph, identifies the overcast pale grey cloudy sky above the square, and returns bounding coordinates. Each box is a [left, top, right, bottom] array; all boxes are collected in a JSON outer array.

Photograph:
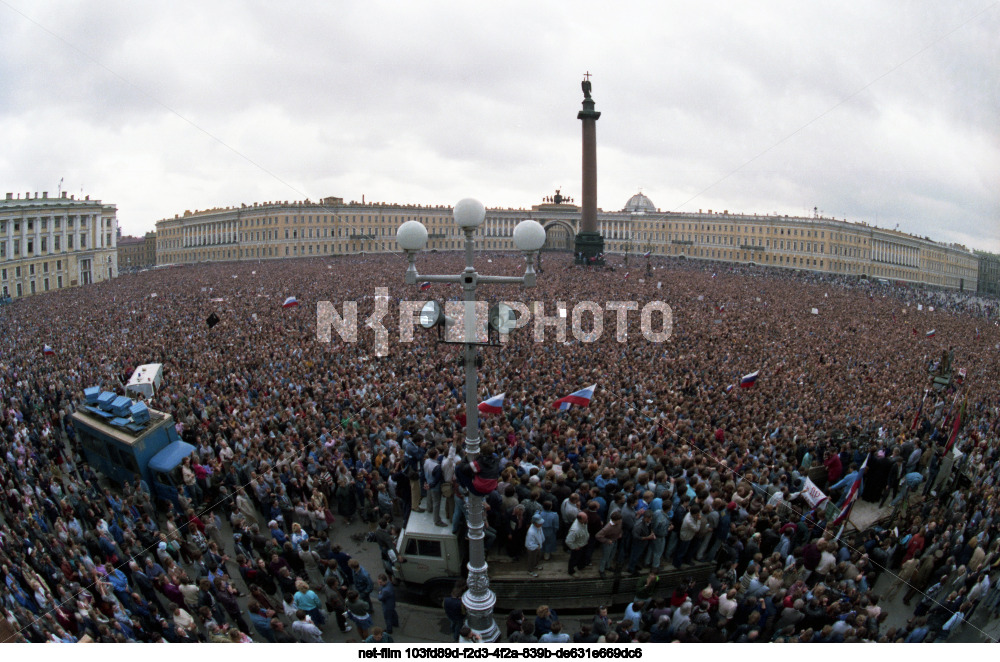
[[0, 0, 1000, 251]]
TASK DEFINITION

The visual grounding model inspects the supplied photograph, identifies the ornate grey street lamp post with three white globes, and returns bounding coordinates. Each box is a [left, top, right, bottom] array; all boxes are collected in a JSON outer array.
[[396, 198, 545, 641]]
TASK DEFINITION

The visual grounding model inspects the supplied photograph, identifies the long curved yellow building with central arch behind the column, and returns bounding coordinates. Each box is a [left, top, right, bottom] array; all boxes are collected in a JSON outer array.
[[156, 191, 979, 291]]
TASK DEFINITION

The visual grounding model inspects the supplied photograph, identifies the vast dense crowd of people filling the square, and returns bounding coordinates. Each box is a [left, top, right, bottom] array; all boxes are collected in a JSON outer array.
[[0, 253, 1000, 642]]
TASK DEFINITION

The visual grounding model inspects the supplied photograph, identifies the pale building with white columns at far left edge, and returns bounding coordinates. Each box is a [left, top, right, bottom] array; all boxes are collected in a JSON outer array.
[[0, 191, 118, 298]]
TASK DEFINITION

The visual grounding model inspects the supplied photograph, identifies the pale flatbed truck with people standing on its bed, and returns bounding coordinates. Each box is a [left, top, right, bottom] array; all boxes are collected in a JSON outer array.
[[395, 512, 715, 611]]
